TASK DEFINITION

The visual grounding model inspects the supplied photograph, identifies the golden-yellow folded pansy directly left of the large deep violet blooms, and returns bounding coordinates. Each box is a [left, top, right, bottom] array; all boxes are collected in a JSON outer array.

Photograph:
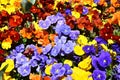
[[78, 56, 92, 70]]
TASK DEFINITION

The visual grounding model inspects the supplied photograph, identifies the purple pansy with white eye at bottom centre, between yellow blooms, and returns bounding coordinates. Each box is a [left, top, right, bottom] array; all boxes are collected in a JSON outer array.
[[50, 63, 66, 77]]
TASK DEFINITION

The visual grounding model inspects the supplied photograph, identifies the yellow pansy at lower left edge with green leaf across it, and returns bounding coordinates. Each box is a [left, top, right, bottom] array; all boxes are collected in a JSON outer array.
[[0, 59, 14, 72]]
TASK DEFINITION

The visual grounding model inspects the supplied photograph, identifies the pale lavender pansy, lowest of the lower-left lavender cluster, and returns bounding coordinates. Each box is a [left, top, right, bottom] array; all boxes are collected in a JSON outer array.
[[17, 63, 31, 77]]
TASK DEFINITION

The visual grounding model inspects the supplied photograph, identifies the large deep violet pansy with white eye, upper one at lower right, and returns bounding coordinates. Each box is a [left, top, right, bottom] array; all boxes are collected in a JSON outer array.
[[98, 50, 112, 68]]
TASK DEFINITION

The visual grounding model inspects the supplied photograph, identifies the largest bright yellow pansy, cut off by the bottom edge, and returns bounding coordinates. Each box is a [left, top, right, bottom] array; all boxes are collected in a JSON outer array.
[[71, 67, 93, 80]]
